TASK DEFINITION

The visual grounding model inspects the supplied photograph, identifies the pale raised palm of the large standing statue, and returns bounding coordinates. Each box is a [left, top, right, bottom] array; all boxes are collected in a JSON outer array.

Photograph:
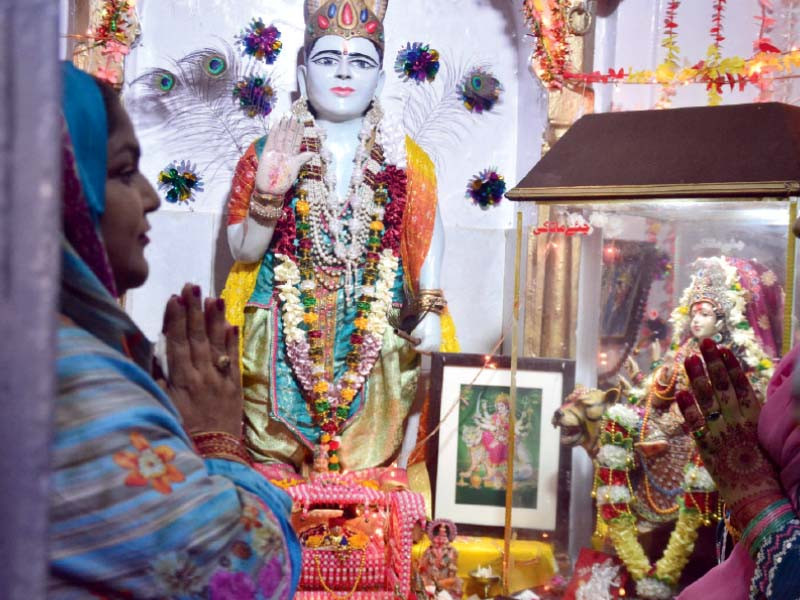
[[256, 117, 314, 196]]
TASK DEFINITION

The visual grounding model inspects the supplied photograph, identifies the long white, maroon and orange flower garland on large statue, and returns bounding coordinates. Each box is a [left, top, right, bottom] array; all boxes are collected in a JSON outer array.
[[275, 176, 405, 471]]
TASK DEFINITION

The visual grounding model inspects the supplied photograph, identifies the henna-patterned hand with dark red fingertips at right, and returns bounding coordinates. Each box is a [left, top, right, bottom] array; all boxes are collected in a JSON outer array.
[[677, 339, 785, 529]]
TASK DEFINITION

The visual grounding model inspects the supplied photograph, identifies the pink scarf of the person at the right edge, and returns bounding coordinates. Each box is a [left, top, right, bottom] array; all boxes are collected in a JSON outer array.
[[678, 346, 800, 600]]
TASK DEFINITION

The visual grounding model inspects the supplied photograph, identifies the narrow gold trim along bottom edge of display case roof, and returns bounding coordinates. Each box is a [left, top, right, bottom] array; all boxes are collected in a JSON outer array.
[[506, 181, 800, 202]]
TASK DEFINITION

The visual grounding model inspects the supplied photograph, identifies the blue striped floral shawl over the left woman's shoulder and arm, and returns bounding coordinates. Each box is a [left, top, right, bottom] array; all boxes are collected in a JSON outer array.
[[48, 328, 299, 600]]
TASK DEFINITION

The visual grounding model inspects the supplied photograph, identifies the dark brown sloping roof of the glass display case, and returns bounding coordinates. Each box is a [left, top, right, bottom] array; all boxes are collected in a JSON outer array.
[[506, 102, 800, 201]]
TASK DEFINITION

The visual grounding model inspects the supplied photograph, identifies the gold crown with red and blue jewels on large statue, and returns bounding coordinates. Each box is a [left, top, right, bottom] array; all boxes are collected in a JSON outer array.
[[305, 0, 389, 53]]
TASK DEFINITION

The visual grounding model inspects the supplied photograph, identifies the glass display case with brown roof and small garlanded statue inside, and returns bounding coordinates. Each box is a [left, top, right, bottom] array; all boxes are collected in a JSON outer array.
[[500, 104, 800, 598]]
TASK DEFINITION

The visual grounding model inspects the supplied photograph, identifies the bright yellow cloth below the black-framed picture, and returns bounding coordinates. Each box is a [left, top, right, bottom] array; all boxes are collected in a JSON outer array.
[[411, 536, 556, 598]]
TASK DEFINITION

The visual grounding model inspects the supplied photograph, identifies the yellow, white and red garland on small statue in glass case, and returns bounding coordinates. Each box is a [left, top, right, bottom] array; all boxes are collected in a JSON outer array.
[[592, 404, 716, 600]]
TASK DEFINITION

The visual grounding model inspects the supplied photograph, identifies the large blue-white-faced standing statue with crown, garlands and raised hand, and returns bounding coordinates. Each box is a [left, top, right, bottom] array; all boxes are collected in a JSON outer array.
[[223, 0, 457, 479]]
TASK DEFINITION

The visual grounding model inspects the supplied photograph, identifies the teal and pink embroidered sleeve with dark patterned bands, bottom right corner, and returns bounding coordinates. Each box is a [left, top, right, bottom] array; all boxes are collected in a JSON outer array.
[[742, 500, 800, 600]]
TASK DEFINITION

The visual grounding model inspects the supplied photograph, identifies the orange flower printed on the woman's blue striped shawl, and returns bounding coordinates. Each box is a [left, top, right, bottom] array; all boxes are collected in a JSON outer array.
[[114, 432, 185, 494]]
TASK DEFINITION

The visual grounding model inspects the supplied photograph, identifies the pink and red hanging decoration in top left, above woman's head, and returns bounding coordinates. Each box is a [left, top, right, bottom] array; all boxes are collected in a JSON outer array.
[[70, 0, 141, 88]]
